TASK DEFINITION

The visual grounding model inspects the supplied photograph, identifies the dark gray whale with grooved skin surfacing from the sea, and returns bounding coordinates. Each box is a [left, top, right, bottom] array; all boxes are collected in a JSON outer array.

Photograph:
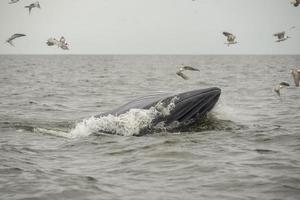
[[95, 87, 221, 134]]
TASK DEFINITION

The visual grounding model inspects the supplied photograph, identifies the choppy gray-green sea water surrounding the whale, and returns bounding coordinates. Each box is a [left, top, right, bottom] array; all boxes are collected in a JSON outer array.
[[0, 55, 300, 200]]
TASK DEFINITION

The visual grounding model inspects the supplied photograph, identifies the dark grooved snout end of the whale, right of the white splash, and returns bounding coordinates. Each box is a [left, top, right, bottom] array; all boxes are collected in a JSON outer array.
[[160, 87, 221, 124]]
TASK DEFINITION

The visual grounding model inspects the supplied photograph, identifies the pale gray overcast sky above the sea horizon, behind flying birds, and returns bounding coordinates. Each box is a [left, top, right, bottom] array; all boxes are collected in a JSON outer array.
[[0, 0, 300, 54]]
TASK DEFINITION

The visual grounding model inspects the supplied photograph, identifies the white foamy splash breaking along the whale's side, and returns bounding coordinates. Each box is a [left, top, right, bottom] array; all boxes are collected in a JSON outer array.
[[69, 97, 178, 138]]
